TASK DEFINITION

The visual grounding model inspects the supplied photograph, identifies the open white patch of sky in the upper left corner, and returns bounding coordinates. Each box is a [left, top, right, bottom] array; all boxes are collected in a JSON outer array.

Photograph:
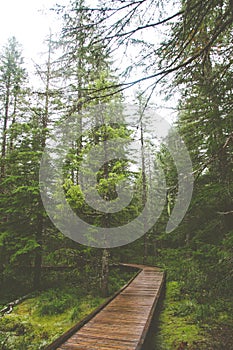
[[0, 0, 68, 60]]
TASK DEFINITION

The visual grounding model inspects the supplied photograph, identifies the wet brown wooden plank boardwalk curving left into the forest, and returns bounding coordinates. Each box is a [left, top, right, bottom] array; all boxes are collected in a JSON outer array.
[[47, 264, 164, 350]]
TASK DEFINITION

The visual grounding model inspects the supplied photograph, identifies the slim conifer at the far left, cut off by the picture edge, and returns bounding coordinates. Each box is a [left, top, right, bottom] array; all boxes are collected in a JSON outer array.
[[0, 37, 27, 286]]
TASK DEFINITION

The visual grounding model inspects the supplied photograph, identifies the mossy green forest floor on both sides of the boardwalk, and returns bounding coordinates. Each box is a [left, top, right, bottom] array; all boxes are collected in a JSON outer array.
[[0, 263, 233, 350]]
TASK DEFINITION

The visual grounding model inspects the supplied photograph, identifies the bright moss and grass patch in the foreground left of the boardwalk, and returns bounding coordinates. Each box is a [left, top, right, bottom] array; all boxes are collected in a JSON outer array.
[[0, 289, 104, 350]]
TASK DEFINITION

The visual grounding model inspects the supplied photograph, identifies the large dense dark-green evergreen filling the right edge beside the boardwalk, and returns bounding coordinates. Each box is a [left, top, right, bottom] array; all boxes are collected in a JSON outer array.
[[149, 2, 233, 304]]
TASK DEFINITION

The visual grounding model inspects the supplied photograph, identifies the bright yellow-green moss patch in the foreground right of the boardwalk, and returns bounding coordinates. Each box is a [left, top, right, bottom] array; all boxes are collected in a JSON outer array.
[[154, 281, 233, 350]]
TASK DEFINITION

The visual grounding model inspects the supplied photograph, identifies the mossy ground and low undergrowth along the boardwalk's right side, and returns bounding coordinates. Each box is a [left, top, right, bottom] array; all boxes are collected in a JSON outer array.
[[153, 247, 233, 350]]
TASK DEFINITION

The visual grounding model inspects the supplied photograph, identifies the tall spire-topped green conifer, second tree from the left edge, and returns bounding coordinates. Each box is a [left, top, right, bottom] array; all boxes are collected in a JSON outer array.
[[0, 33, 61, 289]]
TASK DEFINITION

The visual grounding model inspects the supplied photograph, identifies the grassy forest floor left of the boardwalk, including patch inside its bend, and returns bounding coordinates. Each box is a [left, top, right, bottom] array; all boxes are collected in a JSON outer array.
[[0, 269, 135, 350]]
